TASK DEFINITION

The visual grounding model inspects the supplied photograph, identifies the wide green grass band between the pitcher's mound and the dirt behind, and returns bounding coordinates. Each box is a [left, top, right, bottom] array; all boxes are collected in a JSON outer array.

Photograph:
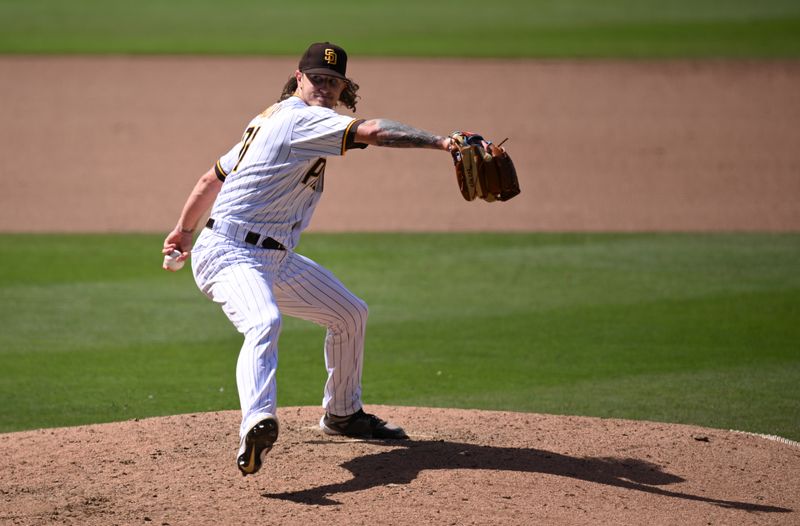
[[0, 234, 800, 440]]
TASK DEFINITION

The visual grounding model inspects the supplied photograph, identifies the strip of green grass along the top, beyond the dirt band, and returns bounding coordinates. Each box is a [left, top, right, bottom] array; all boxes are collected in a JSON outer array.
[[0, 0, 800, 58]]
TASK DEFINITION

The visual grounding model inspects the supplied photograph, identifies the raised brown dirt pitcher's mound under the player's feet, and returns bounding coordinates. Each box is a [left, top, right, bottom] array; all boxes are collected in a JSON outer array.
[[0, 406, 800, 525]]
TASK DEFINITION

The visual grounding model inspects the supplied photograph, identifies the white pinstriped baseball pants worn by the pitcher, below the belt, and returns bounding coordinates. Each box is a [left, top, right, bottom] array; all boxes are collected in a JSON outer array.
[[192, 231, 367, 442]]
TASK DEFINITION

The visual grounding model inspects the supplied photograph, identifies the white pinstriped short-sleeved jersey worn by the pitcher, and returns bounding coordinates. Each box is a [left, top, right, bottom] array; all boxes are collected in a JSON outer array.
[[211, 97, 357, 248]]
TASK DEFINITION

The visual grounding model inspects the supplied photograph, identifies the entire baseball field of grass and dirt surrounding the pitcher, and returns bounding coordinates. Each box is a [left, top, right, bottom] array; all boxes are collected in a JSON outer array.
[[0, 0, 800, 525]]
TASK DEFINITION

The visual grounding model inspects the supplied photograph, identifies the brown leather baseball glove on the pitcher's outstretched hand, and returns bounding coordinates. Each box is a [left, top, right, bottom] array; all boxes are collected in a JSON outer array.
[[450, 131, 520, 203]]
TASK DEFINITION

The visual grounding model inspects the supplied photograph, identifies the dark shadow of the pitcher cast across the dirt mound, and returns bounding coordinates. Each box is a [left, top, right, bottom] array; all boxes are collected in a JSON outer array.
[[262, 441, 793, 513]]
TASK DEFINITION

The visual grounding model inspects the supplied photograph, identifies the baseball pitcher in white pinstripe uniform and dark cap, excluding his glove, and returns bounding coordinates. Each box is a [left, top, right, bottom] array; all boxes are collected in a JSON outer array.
[[163, 42, 453, 475]]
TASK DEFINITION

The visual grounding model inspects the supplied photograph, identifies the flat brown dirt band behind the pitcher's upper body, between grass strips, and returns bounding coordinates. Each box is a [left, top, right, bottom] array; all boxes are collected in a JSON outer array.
[[0, 57, 800, 232]]
